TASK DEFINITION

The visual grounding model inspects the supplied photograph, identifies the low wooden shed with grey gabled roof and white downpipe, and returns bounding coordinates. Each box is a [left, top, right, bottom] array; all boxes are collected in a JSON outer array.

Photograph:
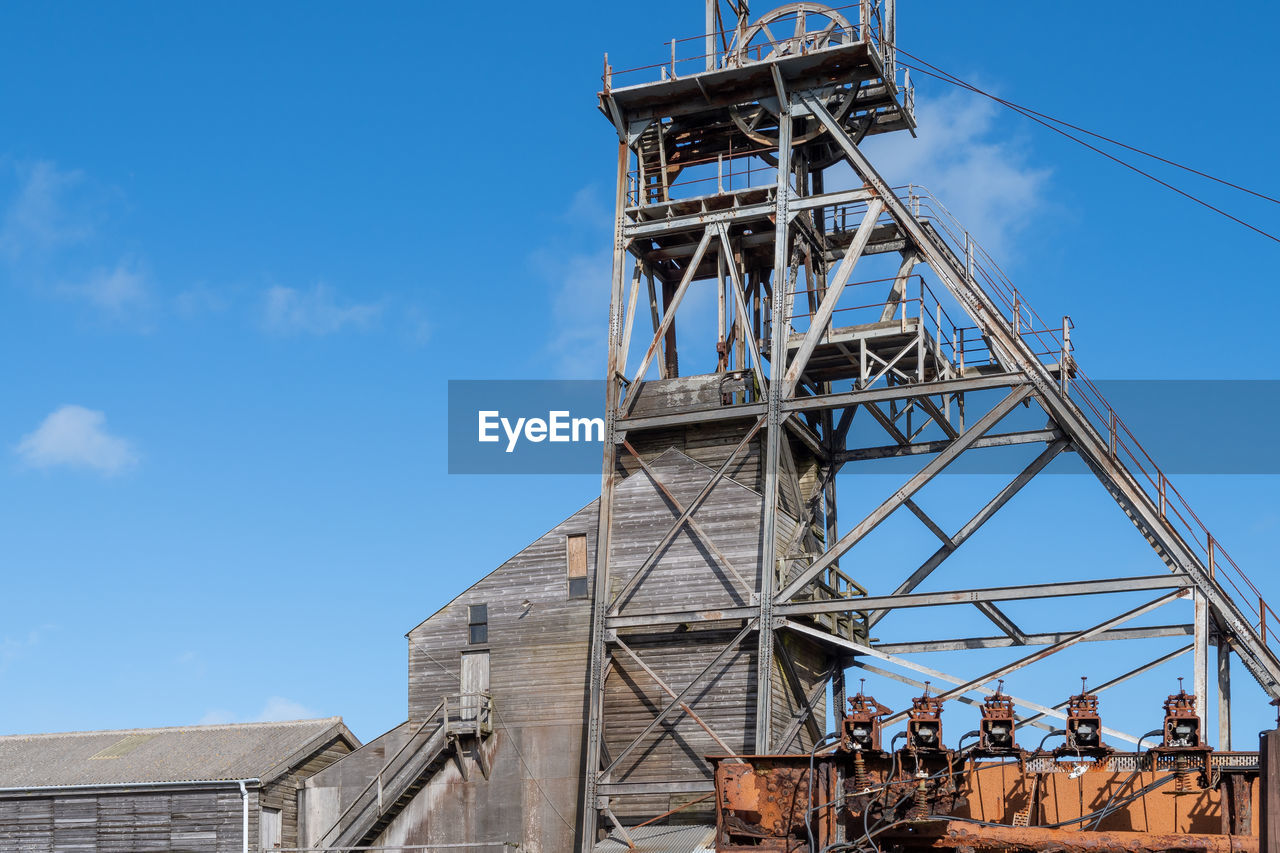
[[0, 717, 361, 853]]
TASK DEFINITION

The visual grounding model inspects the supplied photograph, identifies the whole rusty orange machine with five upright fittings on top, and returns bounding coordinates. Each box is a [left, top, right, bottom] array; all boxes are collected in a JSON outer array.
[[710, 685, 1262, 853]]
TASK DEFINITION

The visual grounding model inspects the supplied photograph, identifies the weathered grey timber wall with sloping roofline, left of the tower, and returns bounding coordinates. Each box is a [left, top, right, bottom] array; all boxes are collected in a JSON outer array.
[[404, 491, 598, 853]]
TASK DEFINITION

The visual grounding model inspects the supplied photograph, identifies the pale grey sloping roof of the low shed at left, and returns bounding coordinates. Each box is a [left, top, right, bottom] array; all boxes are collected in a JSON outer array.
[[0, 717, 360, 788]]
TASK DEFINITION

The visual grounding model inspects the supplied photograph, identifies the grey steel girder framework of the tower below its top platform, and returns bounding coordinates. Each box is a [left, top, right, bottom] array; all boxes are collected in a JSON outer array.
[[582, 61, 1280, 850]]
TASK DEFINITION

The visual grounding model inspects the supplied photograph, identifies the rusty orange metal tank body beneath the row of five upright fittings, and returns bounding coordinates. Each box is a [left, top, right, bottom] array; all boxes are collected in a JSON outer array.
[[716, 753, 1261, 853]]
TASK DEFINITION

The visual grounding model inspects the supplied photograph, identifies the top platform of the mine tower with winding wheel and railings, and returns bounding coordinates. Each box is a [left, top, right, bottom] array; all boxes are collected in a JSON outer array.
[[600, 0, 915, 204]]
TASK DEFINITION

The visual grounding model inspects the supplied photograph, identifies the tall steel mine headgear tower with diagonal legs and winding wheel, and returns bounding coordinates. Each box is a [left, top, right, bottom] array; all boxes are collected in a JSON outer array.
[[581, 0, 1280, 850]]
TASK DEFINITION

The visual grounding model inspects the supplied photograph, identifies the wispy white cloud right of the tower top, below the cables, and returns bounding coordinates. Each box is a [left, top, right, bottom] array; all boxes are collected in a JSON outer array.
[[863, 91, 1051, 259]]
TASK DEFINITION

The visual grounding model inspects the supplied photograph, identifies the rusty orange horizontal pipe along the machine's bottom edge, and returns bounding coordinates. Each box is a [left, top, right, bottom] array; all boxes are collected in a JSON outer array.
[[908, 821, 1258, 853]]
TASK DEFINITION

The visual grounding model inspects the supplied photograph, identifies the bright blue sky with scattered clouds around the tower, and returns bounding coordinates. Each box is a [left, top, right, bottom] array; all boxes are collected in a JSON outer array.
[[0, 0, 1280, 740]]
